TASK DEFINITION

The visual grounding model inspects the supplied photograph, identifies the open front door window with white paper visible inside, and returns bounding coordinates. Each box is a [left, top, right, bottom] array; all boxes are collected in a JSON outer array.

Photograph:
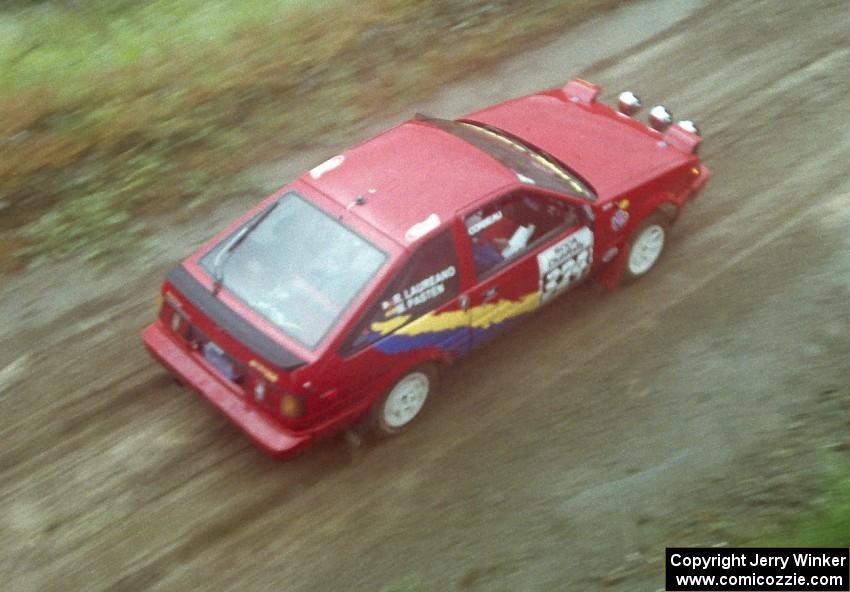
[[464, 191, 578, 279]]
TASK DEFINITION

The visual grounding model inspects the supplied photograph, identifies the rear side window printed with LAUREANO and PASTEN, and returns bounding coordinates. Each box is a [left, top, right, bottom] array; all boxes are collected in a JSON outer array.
[[342, 229, 460, 355]]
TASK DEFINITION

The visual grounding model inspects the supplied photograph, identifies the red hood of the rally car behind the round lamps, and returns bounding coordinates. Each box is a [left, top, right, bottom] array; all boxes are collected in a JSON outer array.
[[463, 90, 693, 201]]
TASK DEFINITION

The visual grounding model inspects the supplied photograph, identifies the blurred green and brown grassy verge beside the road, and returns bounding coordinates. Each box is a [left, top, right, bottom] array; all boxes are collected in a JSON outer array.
[[0, 0, 616, 270]]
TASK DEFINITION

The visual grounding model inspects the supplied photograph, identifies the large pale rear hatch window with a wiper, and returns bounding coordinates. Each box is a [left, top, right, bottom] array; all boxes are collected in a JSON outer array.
[[200, 192, 386, 349]]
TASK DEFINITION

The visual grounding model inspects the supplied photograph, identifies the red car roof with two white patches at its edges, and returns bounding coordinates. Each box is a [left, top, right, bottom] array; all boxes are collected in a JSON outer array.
[[301, 120, 518, 245]]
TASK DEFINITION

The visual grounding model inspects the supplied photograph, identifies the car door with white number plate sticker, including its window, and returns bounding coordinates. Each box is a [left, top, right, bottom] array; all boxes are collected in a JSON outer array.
[[462, 189, 593, 347]]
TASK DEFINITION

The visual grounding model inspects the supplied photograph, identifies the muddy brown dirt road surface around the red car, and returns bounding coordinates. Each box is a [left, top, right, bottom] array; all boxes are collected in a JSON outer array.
[[0, 0, 850, 592]]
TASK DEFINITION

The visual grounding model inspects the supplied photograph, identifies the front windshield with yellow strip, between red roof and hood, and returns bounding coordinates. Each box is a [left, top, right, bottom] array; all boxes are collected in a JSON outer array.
[[421, 117, 596, 201]]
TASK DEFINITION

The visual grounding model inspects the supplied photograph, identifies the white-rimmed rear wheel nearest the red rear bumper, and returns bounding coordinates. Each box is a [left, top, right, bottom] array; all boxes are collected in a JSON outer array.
[[373, 366, 437, 437]]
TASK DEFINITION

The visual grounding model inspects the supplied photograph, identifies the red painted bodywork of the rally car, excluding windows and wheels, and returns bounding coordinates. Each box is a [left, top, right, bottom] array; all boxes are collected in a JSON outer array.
[[143, 81, 710, 457]]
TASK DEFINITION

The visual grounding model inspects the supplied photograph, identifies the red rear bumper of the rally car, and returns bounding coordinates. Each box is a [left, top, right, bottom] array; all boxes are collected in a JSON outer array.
[[142, 321, 316, 458]]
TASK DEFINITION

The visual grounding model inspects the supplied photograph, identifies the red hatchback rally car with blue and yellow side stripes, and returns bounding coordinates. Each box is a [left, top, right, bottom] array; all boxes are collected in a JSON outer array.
[[143, 80, 709, 457]]
